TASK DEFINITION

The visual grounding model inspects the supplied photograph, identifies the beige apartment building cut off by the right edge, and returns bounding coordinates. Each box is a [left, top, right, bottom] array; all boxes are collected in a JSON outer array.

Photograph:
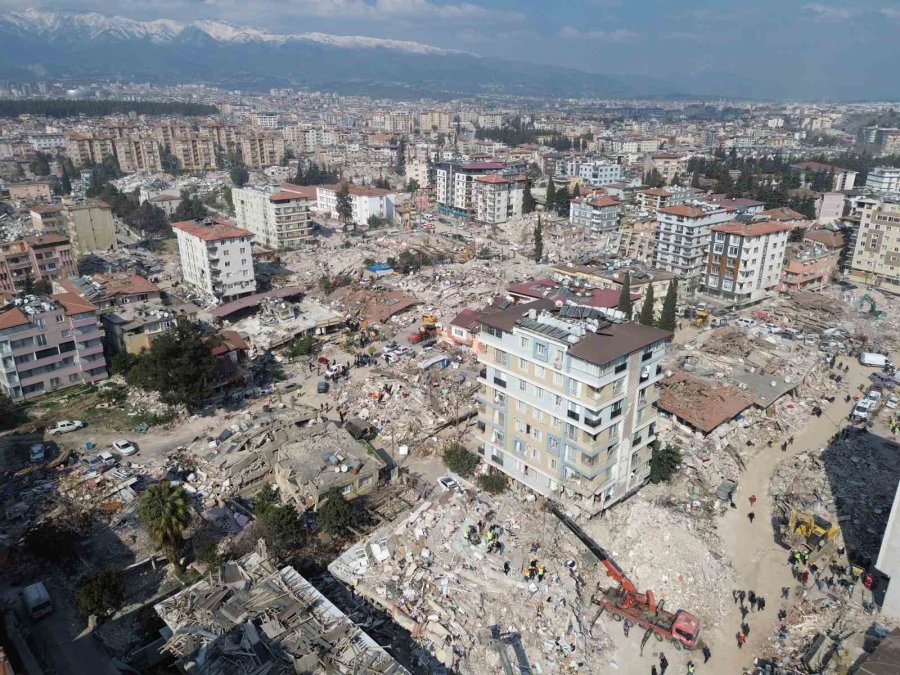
[[850, 199, 900, 293]]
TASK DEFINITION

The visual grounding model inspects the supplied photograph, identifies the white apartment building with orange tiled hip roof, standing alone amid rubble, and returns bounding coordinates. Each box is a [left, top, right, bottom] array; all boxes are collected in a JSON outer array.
[[172, 219, 256, 302]]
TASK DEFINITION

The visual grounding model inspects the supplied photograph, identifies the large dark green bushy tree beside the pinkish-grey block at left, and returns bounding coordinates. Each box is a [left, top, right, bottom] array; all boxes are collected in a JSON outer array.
[[127, 321, 221, 407]]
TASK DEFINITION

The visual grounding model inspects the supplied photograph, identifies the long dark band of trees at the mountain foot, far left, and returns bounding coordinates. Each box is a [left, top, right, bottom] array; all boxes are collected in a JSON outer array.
[[0, 98, 219, 117]]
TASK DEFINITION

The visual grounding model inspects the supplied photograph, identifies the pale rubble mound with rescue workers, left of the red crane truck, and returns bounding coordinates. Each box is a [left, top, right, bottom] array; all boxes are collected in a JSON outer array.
[[329, 491, 612, 673]]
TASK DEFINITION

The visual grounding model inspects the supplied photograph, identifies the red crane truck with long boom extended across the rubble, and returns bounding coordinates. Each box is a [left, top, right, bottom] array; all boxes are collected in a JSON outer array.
[[547, 502, 703, 649]]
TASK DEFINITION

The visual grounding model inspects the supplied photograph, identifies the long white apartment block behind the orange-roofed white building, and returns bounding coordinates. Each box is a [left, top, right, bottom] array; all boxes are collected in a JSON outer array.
[[231, 187, 313, 250]]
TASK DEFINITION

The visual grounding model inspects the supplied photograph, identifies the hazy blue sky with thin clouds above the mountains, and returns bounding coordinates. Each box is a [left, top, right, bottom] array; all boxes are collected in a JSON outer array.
[[0, 0, 900, 98]]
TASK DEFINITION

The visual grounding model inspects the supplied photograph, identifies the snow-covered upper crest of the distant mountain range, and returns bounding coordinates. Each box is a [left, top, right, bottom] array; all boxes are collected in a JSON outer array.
[[0, 9, 459, 54]]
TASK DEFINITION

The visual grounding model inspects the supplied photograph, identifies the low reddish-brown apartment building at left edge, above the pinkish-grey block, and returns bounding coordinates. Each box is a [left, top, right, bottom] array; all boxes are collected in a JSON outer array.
[[0, 234, 76, 292]]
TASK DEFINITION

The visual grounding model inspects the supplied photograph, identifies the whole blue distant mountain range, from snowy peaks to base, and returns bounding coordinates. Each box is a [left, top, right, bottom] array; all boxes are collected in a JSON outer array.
[[0, 10, 633, 98]]
